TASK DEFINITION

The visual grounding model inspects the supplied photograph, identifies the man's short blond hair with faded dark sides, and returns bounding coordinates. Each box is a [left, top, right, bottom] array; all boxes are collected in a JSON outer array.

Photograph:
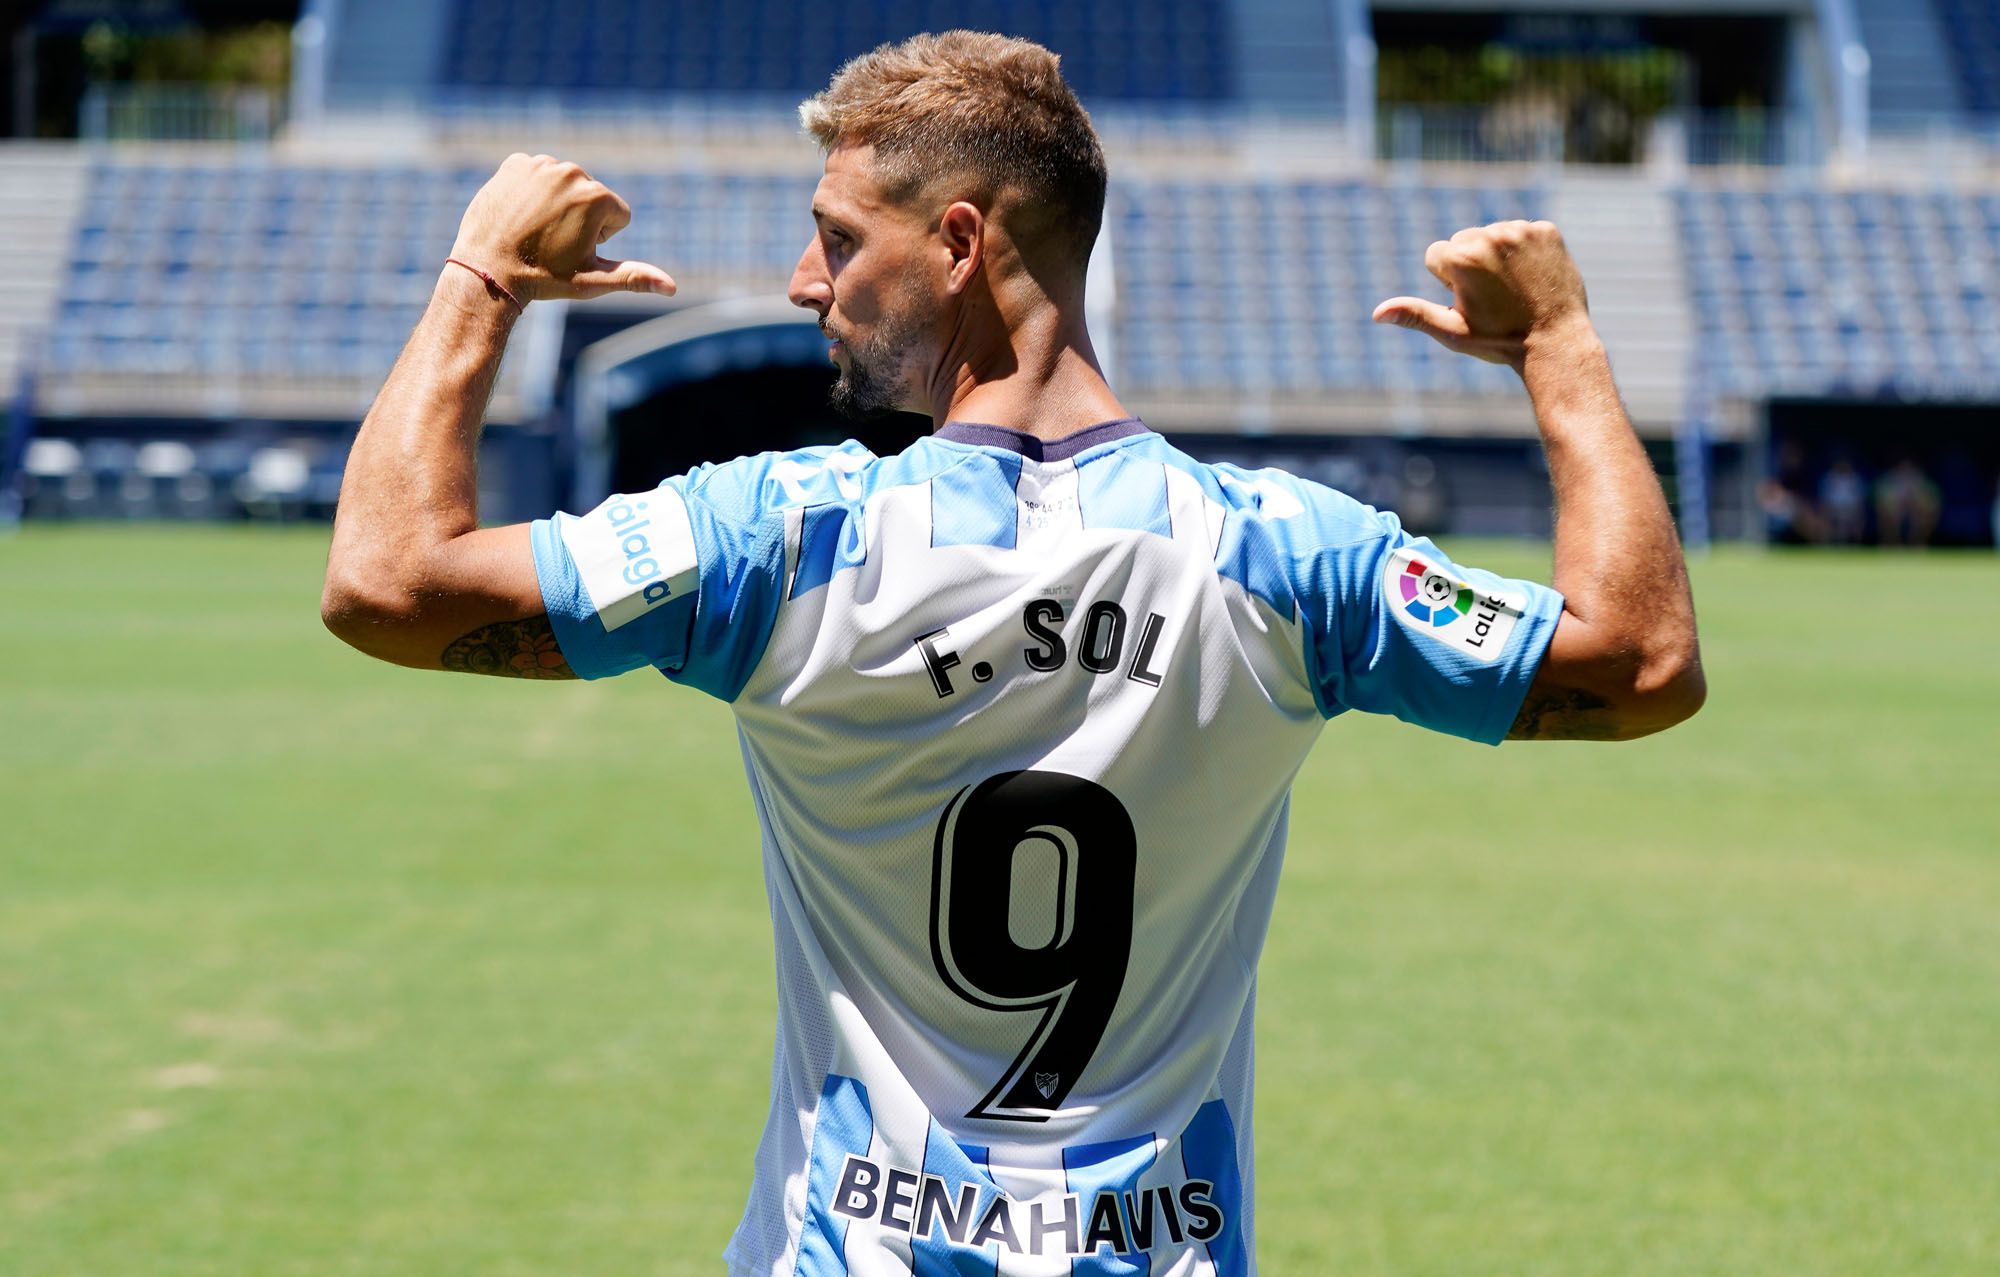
[[798, 30, 1106, 270]]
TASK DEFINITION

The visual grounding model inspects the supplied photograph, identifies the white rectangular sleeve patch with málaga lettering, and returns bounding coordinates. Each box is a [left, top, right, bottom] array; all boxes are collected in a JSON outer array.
[[560, 488, 700, 632]]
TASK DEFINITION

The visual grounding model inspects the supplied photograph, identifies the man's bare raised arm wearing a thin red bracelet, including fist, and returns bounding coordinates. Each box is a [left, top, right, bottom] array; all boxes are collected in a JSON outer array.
[[320, 154, 674, 679]]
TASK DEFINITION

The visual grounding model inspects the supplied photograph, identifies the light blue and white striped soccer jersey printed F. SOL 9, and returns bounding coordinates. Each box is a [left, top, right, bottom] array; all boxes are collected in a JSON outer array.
[[534, 420, 1562, 1277]]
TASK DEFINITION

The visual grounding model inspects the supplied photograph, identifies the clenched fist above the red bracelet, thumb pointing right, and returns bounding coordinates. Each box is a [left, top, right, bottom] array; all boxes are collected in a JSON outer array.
[[452, 154, 674, 302]]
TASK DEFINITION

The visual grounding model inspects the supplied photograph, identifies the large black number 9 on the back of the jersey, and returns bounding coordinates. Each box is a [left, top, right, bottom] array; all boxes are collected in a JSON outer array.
[[930, 771, 1138, 1121]]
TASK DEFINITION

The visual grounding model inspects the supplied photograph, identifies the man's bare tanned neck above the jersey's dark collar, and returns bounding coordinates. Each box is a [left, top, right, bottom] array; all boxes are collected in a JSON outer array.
[[930, 312, 1130, 440]]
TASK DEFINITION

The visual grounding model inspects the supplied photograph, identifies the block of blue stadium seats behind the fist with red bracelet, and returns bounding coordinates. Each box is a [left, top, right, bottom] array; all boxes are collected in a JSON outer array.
[[46, 156, 812, 416]]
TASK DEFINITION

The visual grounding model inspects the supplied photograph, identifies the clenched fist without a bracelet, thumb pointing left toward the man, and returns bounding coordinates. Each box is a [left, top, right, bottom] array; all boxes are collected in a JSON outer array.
[[1374, 222, 1590, 370]]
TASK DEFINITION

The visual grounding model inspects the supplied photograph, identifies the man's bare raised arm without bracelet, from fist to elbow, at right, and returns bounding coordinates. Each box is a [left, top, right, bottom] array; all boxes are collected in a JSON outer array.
[[1374, 222, 1706, 741]]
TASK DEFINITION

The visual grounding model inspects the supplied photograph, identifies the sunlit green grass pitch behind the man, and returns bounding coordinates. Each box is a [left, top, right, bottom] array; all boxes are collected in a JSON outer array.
[[0, 528, 2000, 1277]]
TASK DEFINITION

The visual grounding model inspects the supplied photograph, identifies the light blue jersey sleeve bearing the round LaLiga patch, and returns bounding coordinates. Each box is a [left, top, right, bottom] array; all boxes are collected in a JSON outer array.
[[1224, 472, 1562, 745]]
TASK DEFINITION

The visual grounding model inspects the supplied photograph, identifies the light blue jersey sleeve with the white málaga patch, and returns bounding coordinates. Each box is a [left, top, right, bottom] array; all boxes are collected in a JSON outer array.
[[532, 444, 872, 701]]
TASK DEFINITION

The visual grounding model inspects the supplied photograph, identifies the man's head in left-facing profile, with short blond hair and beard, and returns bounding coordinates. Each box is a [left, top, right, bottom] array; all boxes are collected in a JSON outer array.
[[790, 30, 1104, 414]]
